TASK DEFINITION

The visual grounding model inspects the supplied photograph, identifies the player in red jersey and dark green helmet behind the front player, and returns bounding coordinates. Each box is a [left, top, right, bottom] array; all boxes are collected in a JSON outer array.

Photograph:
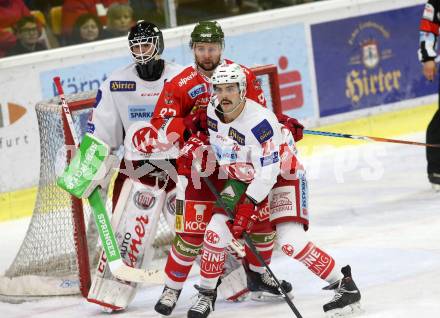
[[152, 21, 300, 315]]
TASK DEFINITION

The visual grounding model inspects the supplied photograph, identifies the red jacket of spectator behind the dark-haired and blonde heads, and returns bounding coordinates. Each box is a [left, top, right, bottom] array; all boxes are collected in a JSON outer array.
[[61, 0, 128, 37]]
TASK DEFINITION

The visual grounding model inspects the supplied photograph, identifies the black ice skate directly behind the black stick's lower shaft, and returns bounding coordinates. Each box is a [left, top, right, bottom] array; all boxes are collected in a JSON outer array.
[[246, 270, 293, 301]]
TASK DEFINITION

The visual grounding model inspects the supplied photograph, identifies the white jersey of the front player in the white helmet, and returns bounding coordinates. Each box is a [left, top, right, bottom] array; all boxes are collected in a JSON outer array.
[[208, 99, 282, 202]]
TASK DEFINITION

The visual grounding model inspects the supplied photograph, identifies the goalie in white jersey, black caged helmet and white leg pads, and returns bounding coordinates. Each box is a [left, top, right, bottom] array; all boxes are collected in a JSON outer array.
[[87, 21, 182, 311]]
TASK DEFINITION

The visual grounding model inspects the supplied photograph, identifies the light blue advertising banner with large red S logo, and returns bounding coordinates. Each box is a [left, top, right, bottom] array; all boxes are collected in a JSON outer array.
[[225, 23, 314, 119]]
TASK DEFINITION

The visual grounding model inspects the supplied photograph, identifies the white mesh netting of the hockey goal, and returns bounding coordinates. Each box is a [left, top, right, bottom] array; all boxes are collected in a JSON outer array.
[[0, 91, 173, 300]]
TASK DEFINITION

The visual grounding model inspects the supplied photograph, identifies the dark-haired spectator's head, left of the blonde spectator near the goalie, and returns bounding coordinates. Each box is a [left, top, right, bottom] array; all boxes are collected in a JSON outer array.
[[66, 13, 102, 44]]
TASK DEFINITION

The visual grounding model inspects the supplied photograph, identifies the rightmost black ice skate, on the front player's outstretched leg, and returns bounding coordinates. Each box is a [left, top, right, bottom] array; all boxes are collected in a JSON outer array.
[[323, 265, 361, 318]]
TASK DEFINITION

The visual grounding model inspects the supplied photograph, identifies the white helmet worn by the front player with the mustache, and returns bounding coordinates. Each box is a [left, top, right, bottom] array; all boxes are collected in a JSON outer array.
[[211, 63, 246, 99]]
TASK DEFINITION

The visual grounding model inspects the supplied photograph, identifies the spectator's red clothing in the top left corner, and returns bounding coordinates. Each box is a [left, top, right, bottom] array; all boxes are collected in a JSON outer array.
[[0, 0, 31, 57]]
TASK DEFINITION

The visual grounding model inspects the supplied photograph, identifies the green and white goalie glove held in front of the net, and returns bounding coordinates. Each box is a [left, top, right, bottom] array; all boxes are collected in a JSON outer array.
[[57, 134, 119, 198]]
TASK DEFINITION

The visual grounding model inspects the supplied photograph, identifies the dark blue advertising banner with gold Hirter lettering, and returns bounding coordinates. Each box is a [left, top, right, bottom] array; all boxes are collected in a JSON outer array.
[[311, 6, 437, 116]]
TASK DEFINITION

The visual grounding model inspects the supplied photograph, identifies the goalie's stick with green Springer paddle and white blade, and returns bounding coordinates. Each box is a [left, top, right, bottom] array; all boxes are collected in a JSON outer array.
[[53, 76, 156, 283]]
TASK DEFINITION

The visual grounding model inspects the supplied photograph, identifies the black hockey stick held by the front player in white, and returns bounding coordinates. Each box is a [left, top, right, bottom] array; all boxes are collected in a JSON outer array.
[[194, 162, 302, 318]]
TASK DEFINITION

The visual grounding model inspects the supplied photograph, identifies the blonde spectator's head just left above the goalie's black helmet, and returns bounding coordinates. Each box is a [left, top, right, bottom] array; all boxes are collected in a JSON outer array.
[[104, 3, 134, 38]]
